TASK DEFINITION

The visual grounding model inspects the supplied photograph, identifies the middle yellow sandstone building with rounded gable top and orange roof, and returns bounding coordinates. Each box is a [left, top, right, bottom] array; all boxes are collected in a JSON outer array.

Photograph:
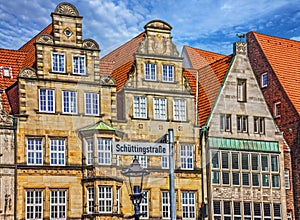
[[100, 20, 202, 219]]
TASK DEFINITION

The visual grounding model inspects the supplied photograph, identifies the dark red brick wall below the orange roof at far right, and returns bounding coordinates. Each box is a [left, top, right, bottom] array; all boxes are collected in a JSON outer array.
[[247, 32, 300, 219]]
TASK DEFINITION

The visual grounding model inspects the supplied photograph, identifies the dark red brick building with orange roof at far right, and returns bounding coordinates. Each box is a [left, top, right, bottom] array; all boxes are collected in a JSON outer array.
[[247, 32, 300, 219]]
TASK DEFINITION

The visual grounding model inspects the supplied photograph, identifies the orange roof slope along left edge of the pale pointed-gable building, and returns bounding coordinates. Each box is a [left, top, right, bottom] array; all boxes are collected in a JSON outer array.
[[184, 55, 233, 126]]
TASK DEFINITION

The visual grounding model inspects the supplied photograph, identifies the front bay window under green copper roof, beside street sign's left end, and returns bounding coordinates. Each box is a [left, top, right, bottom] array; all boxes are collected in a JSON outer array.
[[97, 138, 111, 165]]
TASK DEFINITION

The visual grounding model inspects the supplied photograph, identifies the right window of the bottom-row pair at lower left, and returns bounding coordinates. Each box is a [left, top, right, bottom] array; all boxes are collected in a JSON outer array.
[[50, 190, 67, 219]]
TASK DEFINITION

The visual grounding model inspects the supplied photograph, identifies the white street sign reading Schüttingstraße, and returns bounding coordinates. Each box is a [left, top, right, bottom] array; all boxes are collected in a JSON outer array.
[[112, 142, 169, 156]]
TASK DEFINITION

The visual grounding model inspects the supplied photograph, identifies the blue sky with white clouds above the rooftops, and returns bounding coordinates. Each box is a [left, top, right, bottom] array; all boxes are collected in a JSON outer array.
[[0, 0, 300, 56]]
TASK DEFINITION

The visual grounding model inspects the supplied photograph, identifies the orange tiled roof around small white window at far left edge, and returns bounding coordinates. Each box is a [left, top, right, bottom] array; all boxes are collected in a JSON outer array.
[[0, 49, 27, 112]]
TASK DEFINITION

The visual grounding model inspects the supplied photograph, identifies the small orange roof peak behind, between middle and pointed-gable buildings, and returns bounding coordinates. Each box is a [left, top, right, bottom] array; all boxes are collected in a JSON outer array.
[[182, 46, 225, 69]]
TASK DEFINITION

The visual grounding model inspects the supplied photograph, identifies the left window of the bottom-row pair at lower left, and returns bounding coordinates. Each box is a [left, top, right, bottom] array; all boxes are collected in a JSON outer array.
[[26, 190, 43, 220]]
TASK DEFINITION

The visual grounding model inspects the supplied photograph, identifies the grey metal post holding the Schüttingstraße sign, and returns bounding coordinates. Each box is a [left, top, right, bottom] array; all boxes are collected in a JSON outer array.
[[168, 129, 176, 220]]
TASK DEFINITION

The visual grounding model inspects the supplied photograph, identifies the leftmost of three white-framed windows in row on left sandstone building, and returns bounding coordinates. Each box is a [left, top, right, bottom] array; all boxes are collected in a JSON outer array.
[[39, 89, 55, 113]]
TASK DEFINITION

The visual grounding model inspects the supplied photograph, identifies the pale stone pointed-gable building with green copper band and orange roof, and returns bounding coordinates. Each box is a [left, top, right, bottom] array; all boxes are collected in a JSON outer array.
[[186, 42, 286, 220]]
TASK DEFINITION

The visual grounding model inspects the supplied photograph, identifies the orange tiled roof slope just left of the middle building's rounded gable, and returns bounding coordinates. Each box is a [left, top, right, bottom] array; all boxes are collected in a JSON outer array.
[[100, 33, 144, 91]]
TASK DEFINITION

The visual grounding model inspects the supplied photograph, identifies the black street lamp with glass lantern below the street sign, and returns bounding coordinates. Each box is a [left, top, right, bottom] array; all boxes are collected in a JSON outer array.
[[122, 158, 149, 220]]
